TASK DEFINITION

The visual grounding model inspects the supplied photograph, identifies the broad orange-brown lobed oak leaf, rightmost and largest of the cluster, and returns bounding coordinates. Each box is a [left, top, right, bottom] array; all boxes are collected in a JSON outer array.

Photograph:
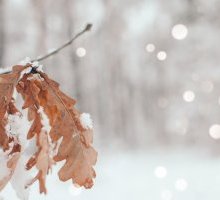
[[39, 72, 97, 188]]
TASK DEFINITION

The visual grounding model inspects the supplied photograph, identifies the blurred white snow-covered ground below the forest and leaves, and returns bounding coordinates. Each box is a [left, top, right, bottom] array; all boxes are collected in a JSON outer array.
[[1, 149, 220, 200]]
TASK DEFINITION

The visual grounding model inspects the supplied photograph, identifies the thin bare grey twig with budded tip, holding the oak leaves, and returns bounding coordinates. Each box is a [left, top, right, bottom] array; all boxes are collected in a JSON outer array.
[[0, 24, 92, 74]]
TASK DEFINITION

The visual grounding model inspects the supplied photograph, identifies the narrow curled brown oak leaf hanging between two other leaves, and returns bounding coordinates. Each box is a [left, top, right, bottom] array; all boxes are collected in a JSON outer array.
[[17, 74, 54, 193]]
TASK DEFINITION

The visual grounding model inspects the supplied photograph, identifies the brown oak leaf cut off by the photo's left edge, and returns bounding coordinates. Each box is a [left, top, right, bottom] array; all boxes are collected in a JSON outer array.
[[0, 65, 25, 190]]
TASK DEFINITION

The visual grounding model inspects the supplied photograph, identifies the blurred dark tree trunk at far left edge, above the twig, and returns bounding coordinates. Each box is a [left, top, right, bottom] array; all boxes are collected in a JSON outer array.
[[0, 0, 5, 66]]
